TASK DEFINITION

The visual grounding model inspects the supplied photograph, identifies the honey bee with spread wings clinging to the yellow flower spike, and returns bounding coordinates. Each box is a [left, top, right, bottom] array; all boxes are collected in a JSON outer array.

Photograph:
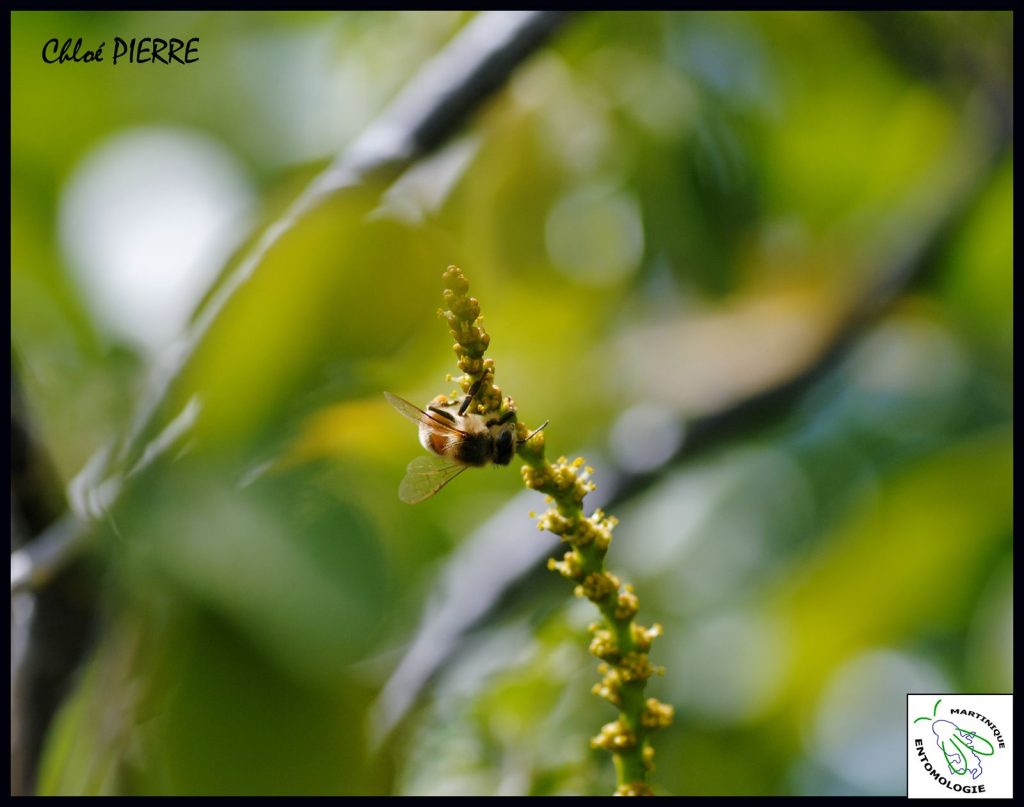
[[384, 381, 548, 504]]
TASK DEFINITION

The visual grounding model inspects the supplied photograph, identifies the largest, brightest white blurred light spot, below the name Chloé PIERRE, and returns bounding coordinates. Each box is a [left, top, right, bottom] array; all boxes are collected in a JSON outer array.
[[59, 128, 253, 354]]
